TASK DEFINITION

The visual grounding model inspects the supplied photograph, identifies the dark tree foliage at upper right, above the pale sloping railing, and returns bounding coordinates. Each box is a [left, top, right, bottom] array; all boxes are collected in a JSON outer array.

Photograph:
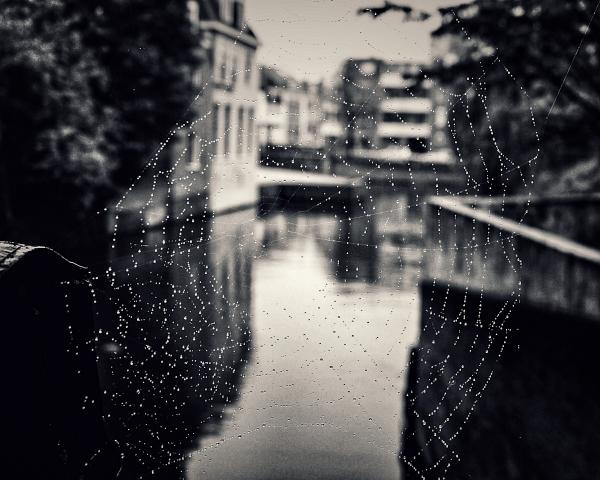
[[360, 0, 600, 194]]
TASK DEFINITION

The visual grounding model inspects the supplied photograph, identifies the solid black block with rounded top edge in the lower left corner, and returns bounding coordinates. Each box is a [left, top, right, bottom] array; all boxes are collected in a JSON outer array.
[[0, 243, 119, 479]]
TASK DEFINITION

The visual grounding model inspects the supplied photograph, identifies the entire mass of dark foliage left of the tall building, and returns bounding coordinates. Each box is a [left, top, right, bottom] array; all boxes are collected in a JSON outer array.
[[0, 0, 198, 258]]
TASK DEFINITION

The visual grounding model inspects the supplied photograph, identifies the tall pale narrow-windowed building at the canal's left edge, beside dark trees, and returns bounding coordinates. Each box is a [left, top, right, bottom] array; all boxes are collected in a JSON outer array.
[[173, 0, 259, 213]]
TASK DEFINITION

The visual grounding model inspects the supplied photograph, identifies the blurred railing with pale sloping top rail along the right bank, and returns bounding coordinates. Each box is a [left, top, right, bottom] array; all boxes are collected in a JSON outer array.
[[425, 195, 600, 319]]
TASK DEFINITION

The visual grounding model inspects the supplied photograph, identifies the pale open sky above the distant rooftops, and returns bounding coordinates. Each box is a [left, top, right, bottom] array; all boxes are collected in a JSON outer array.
[[246, 0, 456, 82]]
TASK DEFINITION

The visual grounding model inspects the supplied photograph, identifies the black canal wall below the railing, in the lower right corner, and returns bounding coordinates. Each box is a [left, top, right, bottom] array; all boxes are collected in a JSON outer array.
[[400, 284, 600, 480]]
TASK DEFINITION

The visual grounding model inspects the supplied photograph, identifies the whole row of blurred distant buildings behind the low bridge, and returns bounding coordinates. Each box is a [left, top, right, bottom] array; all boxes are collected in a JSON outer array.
[[257, 58, 451, 169]]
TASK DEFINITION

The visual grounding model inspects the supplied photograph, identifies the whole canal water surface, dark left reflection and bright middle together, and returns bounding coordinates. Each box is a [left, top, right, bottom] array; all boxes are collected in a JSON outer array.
[[101, 211, 419, 480]]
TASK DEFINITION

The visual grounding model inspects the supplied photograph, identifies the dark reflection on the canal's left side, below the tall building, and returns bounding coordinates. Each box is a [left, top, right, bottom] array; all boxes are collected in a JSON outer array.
[[100, 211, 254, 478]]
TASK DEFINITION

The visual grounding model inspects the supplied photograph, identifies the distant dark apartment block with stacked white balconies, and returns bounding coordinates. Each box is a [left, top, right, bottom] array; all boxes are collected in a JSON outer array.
[[341, 58, 446, 163]]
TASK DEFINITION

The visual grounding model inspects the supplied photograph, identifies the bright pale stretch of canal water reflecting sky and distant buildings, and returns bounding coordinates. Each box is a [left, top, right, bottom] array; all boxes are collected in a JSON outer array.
[[186, 212, 418, 480]]
